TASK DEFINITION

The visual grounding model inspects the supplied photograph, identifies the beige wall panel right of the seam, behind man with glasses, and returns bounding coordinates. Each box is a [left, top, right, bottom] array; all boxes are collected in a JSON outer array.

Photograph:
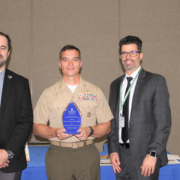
[[120, 0, 180, 155]]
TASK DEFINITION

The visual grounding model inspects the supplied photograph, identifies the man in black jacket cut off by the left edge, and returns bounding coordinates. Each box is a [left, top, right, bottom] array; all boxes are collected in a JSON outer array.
[[0, 32, 33, 180]]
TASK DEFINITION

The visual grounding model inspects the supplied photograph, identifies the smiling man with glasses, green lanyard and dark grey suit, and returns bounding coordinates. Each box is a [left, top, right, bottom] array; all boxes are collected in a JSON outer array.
[[108, 36, 171, 180]]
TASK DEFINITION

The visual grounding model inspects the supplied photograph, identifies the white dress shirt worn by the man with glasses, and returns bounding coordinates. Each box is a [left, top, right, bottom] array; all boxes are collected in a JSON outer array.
[[119, 66, 141, 144]]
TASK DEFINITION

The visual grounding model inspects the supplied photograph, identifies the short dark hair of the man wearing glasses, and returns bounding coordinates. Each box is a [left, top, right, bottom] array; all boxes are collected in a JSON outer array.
[[119, 36, 142, 53]]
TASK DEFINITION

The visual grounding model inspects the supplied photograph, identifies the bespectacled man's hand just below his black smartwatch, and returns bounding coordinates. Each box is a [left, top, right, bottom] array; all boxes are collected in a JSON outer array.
[[140, 154, 157, 177]]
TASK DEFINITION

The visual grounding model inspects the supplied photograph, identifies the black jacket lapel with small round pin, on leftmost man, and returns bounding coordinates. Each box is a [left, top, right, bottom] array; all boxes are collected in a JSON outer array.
[[0, 69, 13, 118]]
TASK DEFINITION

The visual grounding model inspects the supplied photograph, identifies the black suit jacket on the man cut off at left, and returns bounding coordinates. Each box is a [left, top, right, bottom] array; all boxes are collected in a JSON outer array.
[[0, 69, 33, 173]]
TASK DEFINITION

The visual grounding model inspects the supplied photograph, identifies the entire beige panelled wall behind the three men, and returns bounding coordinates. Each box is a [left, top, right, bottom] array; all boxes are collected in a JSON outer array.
[[0, 0, 180, 154]]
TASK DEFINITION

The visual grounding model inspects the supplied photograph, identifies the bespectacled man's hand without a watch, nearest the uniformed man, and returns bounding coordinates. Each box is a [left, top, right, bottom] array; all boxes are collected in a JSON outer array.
[[110, 153, 121, 174]]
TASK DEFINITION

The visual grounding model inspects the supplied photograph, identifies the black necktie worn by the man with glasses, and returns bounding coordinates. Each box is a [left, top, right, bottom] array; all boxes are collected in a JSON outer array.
[[121, 77, 133, 143]]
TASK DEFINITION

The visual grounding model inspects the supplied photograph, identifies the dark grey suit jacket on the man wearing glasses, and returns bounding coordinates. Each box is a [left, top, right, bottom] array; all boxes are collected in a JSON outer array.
[[108, 70, 171, 168]]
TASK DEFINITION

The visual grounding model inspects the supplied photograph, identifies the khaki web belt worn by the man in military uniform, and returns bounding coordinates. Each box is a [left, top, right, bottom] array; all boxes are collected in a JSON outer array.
[[51, 139, 94, 148]]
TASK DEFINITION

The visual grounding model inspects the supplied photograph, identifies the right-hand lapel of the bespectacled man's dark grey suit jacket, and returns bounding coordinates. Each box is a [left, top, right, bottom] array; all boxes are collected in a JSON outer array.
[[131, 69, 146, 113]]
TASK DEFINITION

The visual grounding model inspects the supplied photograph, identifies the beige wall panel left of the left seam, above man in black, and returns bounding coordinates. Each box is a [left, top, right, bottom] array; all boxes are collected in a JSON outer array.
[[0, 0, 32, 83]]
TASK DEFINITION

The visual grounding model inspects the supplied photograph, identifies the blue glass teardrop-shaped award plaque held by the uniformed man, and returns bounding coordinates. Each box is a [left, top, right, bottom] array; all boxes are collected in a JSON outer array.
[[62, 100, 82, 135]]
